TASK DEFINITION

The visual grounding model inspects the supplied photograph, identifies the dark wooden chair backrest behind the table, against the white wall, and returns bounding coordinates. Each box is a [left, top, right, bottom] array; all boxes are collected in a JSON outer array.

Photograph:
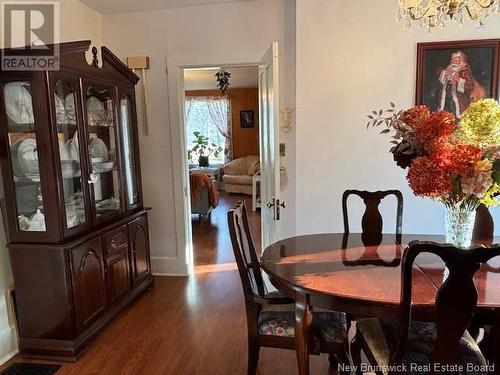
[[342, 190, 403, 243]]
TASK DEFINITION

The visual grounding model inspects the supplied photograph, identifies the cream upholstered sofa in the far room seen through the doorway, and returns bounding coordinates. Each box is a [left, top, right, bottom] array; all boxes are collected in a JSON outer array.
[[222, 155, 260, 195]]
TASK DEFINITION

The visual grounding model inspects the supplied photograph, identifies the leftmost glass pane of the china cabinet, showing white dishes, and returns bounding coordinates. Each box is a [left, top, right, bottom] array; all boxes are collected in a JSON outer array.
[[2, 81, 46, 232]]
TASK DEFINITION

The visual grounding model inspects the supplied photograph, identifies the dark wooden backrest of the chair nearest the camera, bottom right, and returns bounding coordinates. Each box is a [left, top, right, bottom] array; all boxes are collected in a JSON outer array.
[[393, 241, 500, 364]]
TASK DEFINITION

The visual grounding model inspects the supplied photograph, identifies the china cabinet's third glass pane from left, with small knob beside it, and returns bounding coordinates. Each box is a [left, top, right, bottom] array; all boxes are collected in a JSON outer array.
[[85, 87, 122, 218]]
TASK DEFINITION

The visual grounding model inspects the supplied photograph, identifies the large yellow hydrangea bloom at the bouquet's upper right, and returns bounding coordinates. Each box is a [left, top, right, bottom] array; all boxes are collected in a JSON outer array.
[[455, 99, 500, 149]]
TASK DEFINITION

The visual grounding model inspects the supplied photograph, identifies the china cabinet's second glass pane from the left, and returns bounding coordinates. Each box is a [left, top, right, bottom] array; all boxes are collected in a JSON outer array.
[[53, 79, 86, 229]]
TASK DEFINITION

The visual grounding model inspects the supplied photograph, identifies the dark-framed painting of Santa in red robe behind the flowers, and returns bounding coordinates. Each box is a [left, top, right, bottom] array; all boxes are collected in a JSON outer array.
[[416, 39, 500, 118]]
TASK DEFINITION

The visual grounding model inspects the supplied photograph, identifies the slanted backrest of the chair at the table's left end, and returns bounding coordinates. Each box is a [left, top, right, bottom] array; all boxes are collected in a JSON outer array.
[[227, 202, 265, 297]]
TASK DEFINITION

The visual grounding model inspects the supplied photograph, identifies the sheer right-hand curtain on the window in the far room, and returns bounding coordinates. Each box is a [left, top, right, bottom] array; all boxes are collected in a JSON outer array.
[[205, 96, 233, 163]]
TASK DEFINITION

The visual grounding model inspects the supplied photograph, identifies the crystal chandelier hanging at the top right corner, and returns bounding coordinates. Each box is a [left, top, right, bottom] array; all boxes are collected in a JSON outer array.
[[398, 0, 500, 30]]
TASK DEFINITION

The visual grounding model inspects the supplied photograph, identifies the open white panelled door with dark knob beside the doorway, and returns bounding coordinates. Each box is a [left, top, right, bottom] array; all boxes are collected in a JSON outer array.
[[259, 42, 284, 249]]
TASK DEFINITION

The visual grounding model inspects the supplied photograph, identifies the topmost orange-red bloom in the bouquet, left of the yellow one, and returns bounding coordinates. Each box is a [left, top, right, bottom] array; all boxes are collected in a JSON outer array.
[[415, 111, 456, 149]]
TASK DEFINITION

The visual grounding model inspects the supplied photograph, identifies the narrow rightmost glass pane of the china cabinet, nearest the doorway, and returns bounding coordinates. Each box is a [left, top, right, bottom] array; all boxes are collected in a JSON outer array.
[[120, 95, 139, 208]]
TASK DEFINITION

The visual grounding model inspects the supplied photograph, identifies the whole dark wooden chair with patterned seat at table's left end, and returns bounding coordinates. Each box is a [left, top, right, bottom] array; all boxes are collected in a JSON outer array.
[[227, 202, 349, 375]]
